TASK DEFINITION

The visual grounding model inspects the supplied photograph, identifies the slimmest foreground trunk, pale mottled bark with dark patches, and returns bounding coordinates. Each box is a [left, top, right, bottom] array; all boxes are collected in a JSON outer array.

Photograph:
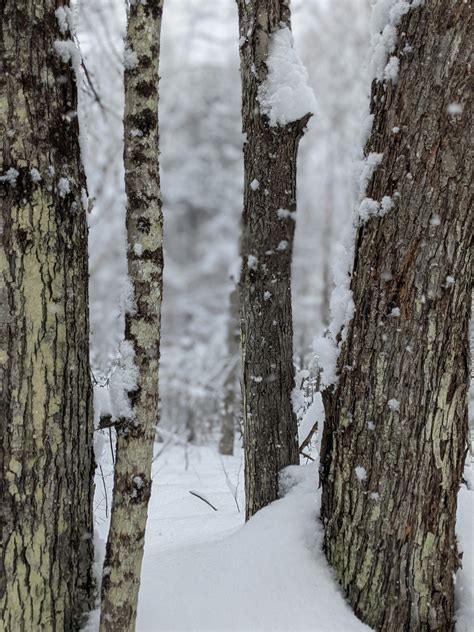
[[100, 0, 163, 632]]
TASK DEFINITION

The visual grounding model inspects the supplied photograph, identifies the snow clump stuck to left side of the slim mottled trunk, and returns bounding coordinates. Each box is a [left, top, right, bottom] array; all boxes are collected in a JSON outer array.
[[109, 340, 138, 419]]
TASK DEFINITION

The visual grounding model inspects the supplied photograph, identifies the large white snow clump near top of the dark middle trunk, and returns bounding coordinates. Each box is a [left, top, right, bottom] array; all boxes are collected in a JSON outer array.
[[258, 27, 316, 127]]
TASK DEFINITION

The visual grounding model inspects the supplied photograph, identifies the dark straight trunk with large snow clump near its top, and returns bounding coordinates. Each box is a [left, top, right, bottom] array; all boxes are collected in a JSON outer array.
[[238, 0, 312, 518]]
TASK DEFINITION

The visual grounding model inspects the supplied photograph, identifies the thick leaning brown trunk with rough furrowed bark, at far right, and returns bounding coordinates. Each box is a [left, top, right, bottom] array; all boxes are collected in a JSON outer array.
[[321, 0, 474, 632]]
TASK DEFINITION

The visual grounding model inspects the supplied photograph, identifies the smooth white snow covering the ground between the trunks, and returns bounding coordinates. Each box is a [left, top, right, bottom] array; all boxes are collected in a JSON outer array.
[[86, 444, 474, 632]]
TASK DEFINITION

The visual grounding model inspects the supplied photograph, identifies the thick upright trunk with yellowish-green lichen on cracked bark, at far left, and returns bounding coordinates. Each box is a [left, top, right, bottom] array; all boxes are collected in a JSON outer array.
[[0, 0, 94, 632]]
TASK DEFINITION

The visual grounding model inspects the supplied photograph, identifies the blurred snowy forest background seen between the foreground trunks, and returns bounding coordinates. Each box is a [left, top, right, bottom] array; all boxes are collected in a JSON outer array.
[[78, 0, 370, 441]]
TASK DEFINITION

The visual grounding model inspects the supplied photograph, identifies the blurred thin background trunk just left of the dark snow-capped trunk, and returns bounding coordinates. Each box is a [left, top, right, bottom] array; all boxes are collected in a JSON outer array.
[[219, 285, 240, 455]]
